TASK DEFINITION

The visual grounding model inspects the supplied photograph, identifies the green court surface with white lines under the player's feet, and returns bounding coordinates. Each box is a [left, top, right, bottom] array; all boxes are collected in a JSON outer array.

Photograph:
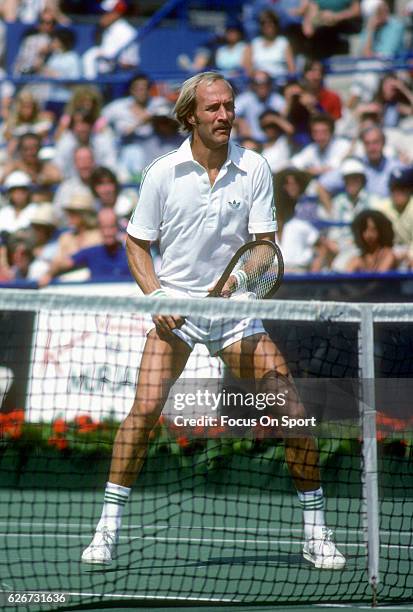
[[0, 489, 413, 611]]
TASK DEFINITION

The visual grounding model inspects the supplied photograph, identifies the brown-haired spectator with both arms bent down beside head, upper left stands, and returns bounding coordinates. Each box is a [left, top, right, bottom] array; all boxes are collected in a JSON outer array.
[[54, 85, 106, 141]]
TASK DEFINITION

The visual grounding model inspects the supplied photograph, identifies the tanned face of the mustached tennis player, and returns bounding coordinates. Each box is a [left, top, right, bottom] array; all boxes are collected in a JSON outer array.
[[188, 80, 235, 149]]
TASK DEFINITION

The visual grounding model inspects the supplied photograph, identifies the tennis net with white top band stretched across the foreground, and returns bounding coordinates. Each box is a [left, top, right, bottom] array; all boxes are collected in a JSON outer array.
[[0, 290, 413, 610]]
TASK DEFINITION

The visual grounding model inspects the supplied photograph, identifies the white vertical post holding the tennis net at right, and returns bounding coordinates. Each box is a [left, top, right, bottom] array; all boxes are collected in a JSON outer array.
[[359, 304, 380, 607]]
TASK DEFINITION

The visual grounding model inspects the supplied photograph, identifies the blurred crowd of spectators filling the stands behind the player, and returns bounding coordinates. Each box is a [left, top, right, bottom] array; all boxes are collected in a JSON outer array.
[[0, 0, 413, 286]]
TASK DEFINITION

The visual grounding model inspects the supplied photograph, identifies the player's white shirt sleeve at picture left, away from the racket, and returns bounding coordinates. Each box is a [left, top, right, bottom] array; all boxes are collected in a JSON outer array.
[[126, 166, 162, 242]]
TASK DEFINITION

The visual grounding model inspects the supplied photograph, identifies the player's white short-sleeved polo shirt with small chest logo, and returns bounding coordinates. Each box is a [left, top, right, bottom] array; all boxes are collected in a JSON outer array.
[[127, 138, 277, 297]]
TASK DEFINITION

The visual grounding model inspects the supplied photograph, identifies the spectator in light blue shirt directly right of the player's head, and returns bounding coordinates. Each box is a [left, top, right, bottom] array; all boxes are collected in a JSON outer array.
[[235, 70, 285, 142]]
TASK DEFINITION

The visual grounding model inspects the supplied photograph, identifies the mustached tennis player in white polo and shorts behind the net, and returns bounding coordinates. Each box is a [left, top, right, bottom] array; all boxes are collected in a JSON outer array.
[[82, 72, 345, 569]]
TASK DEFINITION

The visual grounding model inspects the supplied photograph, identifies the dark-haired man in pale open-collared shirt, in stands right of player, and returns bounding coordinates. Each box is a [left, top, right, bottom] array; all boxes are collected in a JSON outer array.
[[291, 114, 350, 178]]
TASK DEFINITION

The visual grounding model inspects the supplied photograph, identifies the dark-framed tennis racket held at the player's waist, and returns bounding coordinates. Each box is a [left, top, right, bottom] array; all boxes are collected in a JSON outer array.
[[209, 240, 284, 300]]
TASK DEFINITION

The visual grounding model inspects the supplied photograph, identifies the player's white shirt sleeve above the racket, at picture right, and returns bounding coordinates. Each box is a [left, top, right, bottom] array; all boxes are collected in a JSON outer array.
[[248, 158, 277, 234]]
